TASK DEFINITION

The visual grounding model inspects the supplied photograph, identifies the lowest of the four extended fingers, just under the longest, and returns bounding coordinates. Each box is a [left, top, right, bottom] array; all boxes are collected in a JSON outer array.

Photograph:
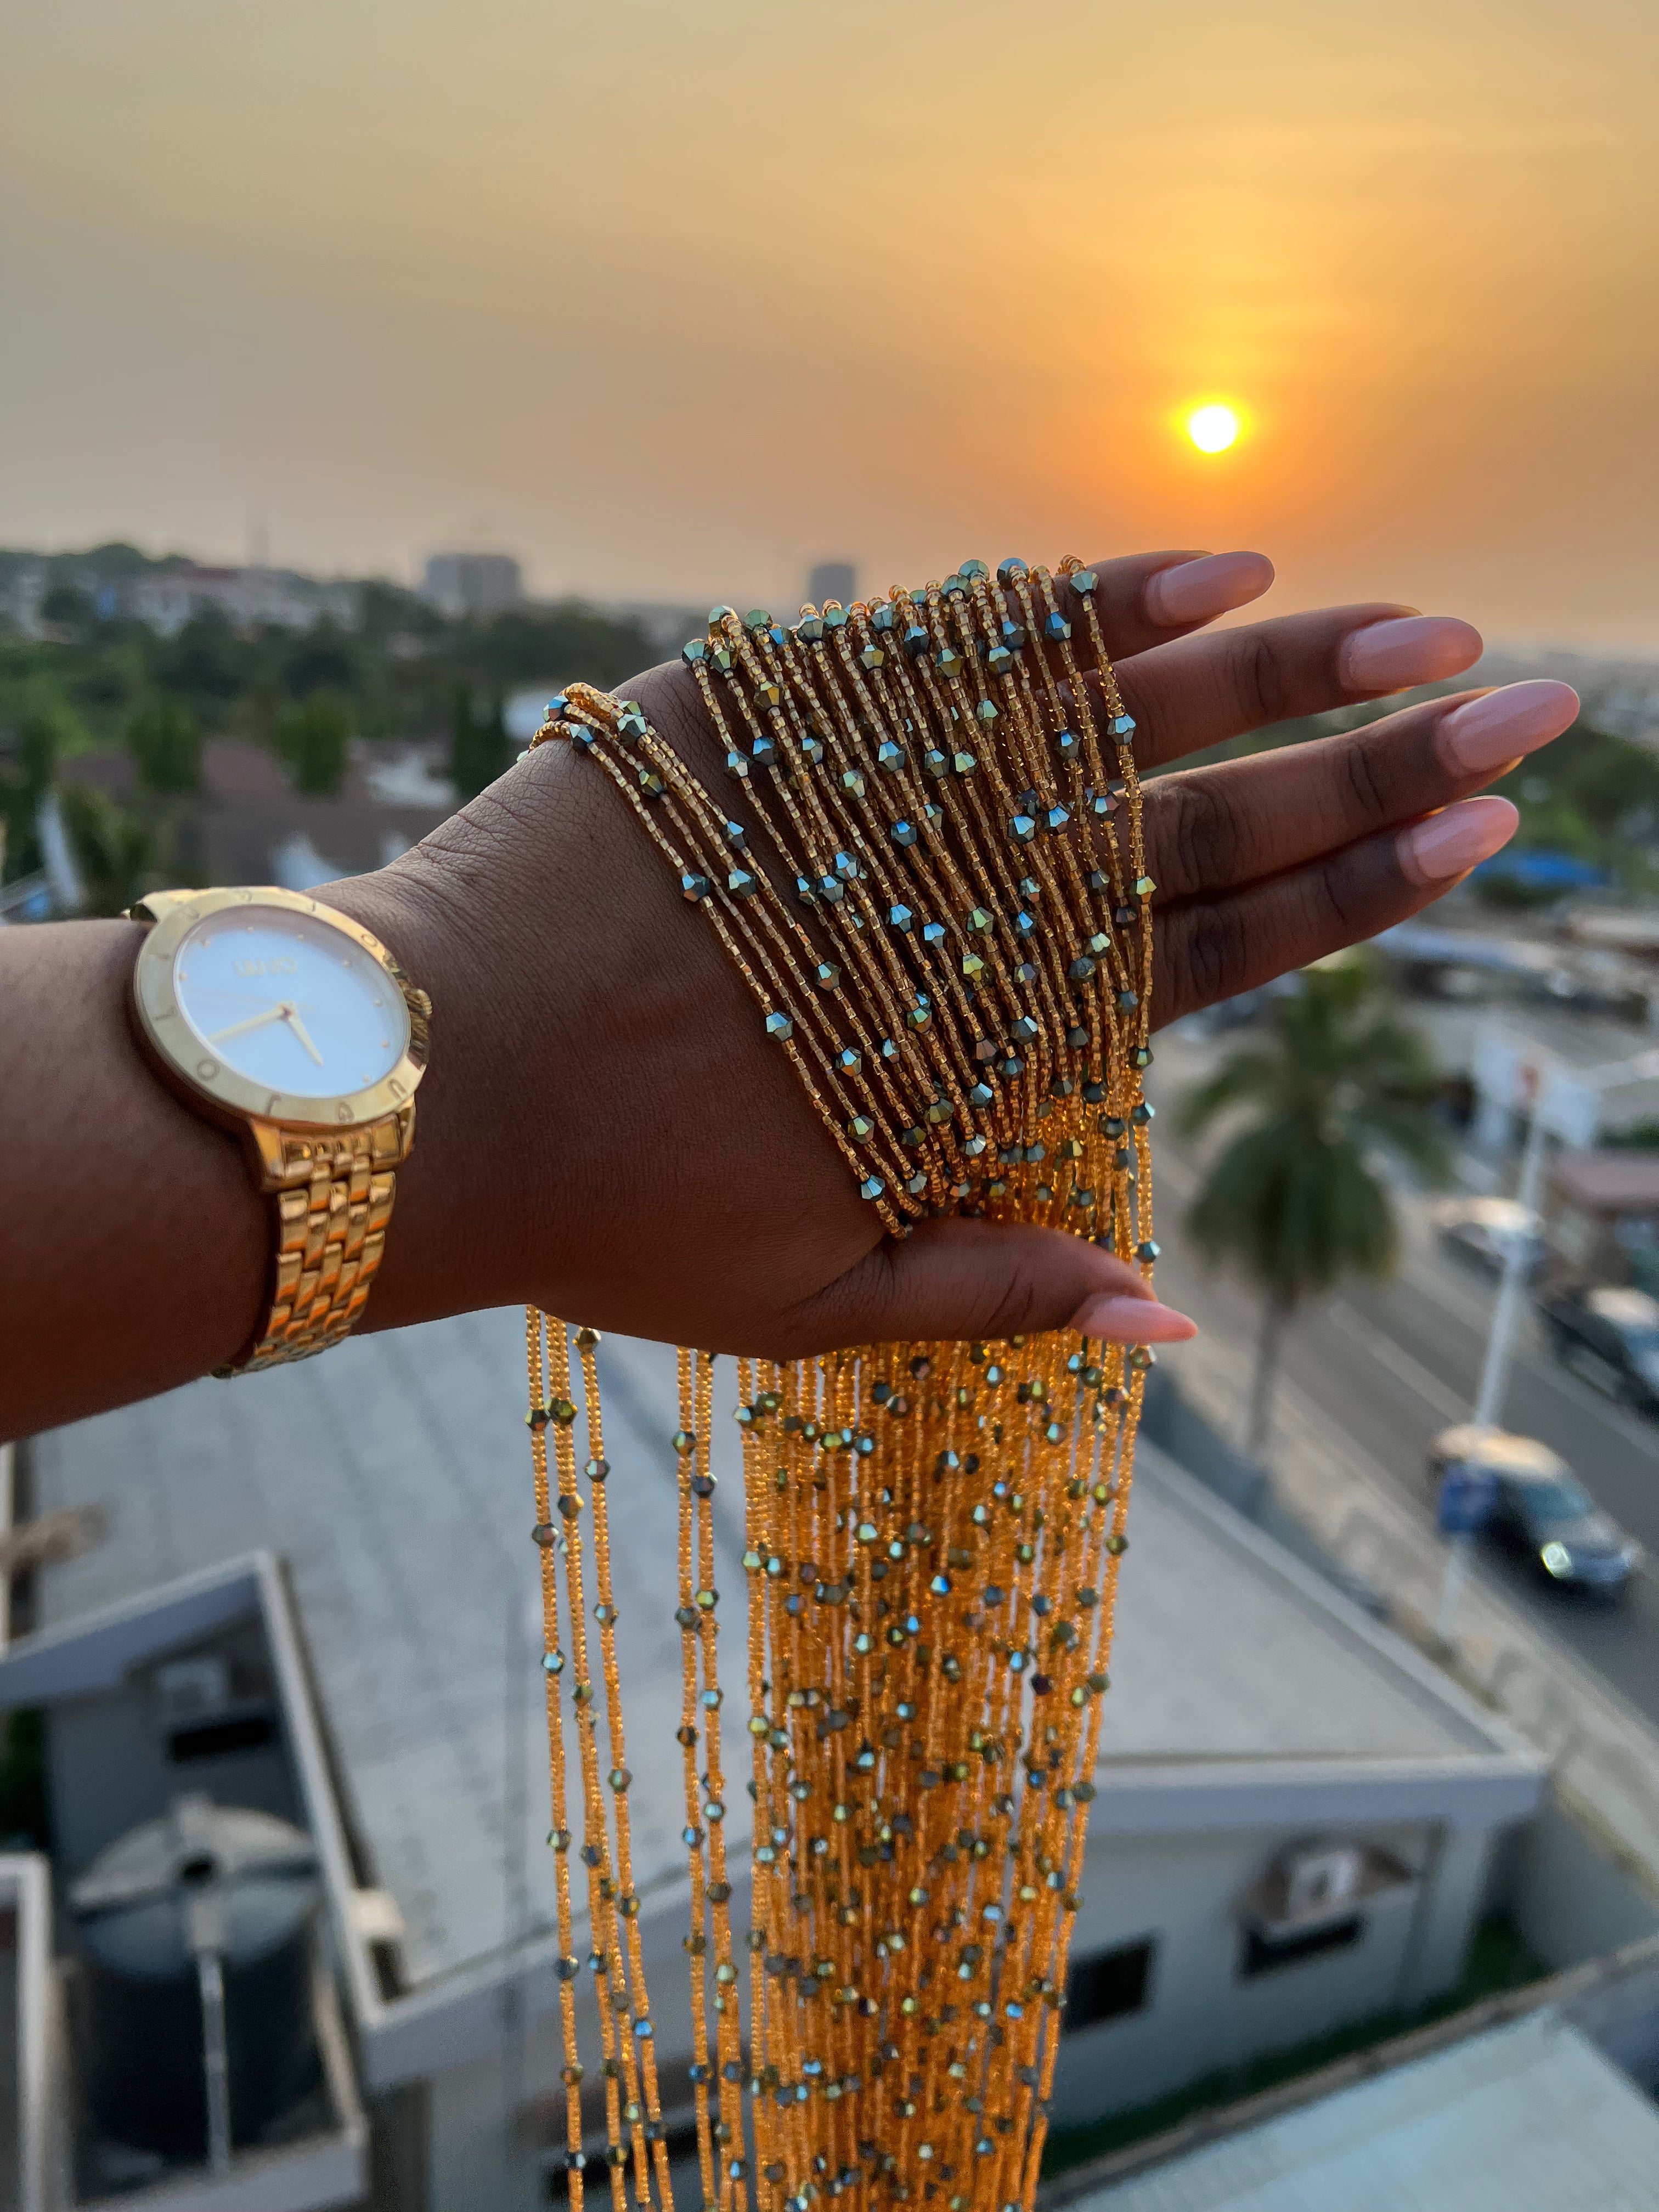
[[1153, 799, 1520, 1024]]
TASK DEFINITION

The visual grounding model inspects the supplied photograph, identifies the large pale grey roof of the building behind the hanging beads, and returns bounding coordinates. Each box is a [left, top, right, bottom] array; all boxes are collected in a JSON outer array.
[[22, 1310, 1539, 1987]]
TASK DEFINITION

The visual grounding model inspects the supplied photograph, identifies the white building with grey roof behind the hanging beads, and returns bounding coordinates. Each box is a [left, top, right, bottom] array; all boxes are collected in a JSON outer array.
[[0, 1314, 1544, 2212]]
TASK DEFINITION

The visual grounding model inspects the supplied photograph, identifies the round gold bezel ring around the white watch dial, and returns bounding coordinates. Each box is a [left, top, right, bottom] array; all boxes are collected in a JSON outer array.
[[131, 885, 429, 1130]]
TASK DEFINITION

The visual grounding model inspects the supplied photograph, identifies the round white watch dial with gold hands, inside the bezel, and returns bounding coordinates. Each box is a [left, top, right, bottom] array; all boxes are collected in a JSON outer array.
[[172, 905, 409, 1099]]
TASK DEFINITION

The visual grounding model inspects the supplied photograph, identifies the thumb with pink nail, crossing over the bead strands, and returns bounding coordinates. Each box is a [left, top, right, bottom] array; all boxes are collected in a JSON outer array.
[[789, 1217, 1197, 1350]]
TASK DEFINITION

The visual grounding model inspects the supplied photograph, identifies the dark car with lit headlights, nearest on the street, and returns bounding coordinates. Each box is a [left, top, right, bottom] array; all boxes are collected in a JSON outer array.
[[1429, 1423, 1641, 1597]]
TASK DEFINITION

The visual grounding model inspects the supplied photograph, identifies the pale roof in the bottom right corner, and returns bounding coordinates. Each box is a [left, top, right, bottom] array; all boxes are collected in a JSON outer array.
[[1066, 2008, 1659, 2212]]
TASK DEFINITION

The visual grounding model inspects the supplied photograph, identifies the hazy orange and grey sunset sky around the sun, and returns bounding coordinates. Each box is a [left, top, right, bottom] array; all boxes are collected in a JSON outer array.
[[0, 0, 1659, 648]]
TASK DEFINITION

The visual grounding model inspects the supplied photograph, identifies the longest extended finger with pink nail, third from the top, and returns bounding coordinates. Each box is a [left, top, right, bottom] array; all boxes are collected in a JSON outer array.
[[1146, 679, 1579, 900]]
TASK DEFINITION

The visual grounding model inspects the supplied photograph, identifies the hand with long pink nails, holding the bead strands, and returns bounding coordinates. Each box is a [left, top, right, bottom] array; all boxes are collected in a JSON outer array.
[[334, 553, 1577, 1356]]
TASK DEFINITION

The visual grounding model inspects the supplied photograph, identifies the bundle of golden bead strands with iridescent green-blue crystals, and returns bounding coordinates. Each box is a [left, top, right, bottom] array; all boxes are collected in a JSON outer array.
[[529, 562, 1157, 2212]]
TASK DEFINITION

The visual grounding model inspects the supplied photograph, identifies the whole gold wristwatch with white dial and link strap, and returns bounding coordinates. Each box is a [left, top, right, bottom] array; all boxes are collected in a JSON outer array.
[[128, 889, 431, 1376]]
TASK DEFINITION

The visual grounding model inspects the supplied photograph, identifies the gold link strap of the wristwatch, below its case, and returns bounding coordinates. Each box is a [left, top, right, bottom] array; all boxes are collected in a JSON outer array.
[[228, 1104, 414, 1376]]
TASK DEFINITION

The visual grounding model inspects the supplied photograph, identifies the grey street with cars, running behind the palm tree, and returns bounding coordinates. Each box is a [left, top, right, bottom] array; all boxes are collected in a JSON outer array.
[[1155, 1035, 1659, 1723]]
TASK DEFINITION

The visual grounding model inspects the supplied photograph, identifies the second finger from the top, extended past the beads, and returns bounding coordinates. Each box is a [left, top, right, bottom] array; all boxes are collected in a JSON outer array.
[[1117, 606, 1482, 770]]
